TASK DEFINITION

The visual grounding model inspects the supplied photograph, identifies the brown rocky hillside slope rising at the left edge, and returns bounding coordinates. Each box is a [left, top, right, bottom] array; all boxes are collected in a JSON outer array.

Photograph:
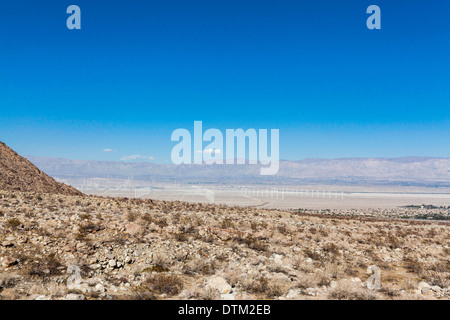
[[0, 142, 82, 195]]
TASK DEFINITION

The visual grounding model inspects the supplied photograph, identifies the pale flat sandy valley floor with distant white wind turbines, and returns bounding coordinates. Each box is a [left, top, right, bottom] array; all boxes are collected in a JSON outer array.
[[82, 185, 450, 209]]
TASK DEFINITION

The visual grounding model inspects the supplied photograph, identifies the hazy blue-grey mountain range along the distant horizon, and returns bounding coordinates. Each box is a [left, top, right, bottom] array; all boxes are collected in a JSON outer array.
[[27, 156, 450, 187]]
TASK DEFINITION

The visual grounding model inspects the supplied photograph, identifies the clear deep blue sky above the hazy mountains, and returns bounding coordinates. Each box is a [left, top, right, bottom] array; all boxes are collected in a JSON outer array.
[[0, 0, 450, 163]]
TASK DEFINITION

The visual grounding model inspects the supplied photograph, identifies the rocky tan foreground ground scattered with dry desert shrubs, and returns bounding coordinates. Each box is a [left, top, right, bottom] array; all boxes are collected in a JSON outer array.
[[0, 191, 450, 300]]
